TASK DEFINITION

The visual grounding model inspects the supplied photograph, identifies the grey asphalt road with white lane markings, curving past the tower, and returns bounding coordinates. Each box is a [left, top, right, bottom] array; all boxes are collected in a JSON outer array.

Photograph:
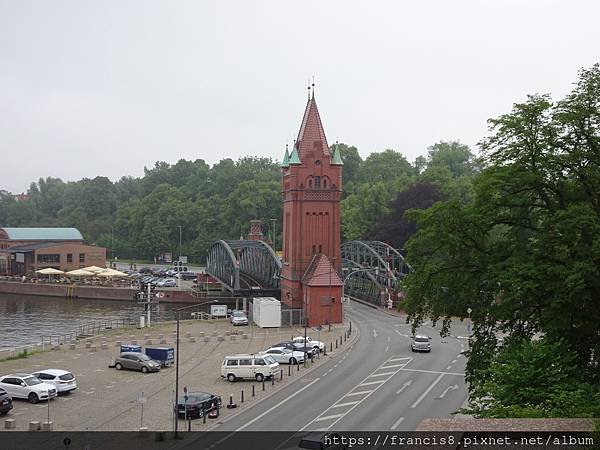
[[215, 302, 467, 436]]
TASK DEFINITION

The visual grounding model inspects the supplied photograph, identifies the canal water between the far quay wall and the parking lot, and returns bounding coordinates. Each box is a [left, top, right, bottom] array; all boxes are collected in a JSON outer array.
[[0, 294, 181, 349]]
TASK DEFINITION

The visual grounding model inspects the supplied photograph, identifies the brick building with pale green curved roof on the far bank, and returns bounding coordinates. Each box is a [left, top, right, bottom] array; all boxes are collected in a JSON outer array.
[[0, 228, 106, 275]]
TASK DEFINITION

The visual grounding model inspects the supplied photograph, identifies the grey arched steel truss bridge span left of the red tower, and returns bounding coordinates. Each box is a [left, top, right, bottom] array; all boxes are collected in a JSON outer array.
[[206, 240, 281, 297]]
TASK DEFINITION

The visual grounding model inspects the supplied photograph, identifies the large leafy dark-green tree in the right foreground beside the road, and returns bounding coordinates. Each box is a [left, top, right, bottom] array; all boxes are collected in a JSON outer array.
[[406, 65, 600, 415]]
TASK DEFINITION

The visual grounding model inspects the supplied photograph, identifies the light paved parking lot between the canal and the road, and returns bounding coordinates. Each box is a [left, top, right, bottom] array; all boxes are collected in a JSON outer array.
[[0, 320, 348, 431]]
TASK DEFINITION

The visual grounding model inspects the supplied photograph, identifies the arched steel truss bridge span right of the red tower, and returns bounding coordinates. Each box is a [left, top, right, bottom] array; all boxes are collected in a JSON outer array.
[[341, 241, 410, 305]]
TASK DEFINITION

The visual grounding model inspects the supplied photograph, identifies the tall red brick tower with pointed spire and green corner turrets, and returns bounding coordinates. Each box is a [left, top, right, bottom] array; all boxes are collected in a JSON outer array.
[[281, 88, 342, 326]]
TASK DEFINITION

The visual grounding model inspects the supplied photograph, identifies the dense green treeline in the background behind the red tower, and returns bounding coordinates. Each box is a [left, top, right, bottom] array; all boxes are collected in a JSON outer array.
[[0, 142, 477, 263]]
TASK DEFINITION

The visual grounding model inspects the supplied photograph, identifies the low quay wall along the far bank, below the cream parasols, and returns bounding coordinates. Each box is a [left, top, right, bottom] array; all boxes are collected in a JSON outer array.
[[0, 281, 199, 303]]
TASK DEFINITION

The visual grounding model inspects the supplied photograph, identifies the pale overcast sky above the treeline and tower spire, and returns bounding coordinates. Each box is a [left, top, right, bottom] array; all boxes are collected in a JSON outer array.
[[0, 0, 600, 193]]
